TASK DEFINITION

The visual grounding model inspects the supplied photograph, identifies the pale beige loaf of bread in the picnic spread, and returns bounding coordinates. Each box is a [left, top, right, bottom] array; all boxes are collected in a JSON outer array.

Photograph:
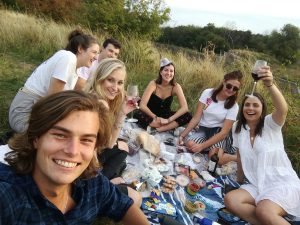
[[136, 131, 160, 156]]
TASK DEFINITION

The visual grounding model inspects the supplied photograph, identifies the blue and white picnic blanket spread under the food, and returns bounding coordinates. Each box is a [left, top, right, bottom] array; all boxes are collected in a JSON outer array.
[[121, 123, 299, 225]]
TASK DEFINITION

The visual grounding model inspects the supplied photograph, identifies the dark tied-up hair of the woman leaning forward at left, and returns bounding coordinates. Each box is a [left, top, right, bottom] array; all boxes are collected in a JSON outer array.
[[65, 29, 98, 55]]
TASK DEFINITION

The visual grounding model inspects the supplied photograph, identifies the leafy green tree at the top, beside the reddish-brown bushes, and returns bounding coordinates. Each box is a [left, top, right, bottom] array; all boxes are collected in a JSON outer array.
[[78, 0, 170, 39]]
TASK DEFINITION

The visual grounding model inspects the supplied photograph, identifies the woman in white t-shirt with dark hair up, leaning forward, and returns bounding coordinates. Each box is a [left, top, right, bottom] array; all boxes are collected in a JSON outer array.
[[9, 30, 99, 133]]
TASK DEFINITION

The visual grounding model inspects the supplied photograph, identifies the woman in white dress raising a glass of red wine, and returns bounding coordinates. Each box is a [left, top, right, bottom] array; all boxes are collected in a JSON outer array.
[[224, 66, 300, 225]]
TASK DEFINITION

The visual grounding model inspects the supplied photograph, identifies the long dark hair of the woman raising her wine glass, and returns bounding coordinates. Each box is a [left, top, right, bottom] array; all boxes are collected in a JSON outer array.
[[235, 92, 267, 136]]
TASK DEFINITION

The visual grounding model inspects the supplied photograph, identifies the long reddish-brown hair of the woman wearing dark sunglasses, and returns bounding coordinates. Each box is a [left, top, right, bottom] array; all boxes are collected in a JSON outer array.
[[211, 70, 243, 109]]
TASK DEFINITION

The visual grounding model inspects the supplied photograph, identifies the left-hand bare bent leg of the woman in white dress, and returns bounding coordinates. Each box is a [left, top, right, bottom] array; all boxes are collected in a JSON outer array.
[[224, 188, 262, 225]]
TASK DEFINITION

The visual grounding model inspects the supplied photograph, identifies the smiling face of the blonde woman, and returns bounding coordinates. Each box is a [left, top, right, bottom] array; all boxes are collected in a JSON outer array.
[[102, 69, 126, 100]]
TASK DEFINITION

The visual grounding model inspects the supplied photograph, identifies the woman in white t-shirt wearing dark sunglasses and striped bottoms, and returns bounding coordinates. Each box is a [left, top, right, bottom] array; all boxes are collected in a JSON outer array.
[[179, 71, 243, 165]]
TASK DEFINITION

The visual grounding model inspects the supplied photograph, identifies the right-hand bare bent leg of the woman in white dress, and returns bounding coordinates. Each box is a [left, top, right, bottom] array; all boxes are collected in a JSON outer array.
[[256, 199, 290, 225]]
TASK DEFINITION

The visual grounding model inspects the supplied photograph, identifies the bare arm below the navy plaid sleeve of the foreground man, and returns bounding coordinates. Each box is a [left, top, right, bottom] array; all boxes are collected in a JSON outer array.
[[122, 204, 150, 225]]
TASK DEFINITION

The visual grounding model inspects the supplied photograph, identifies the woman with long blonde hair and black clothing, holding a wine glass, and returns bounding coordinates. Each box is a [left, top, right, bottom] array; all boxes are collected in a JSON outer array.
[[84, 58, 141, 205]]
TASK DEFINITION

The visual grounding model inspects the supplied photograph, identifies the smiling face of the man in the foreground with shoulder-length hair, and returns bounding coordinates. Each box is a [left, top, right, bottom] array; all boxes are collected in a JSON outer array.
[[33, 111, 99, 188]]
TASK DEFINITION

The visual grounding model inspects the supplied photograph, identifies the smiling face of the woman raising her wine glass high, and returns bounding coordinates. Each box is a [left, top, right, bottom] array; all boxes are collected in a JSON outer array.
[[243, 96, 262, 122]]
